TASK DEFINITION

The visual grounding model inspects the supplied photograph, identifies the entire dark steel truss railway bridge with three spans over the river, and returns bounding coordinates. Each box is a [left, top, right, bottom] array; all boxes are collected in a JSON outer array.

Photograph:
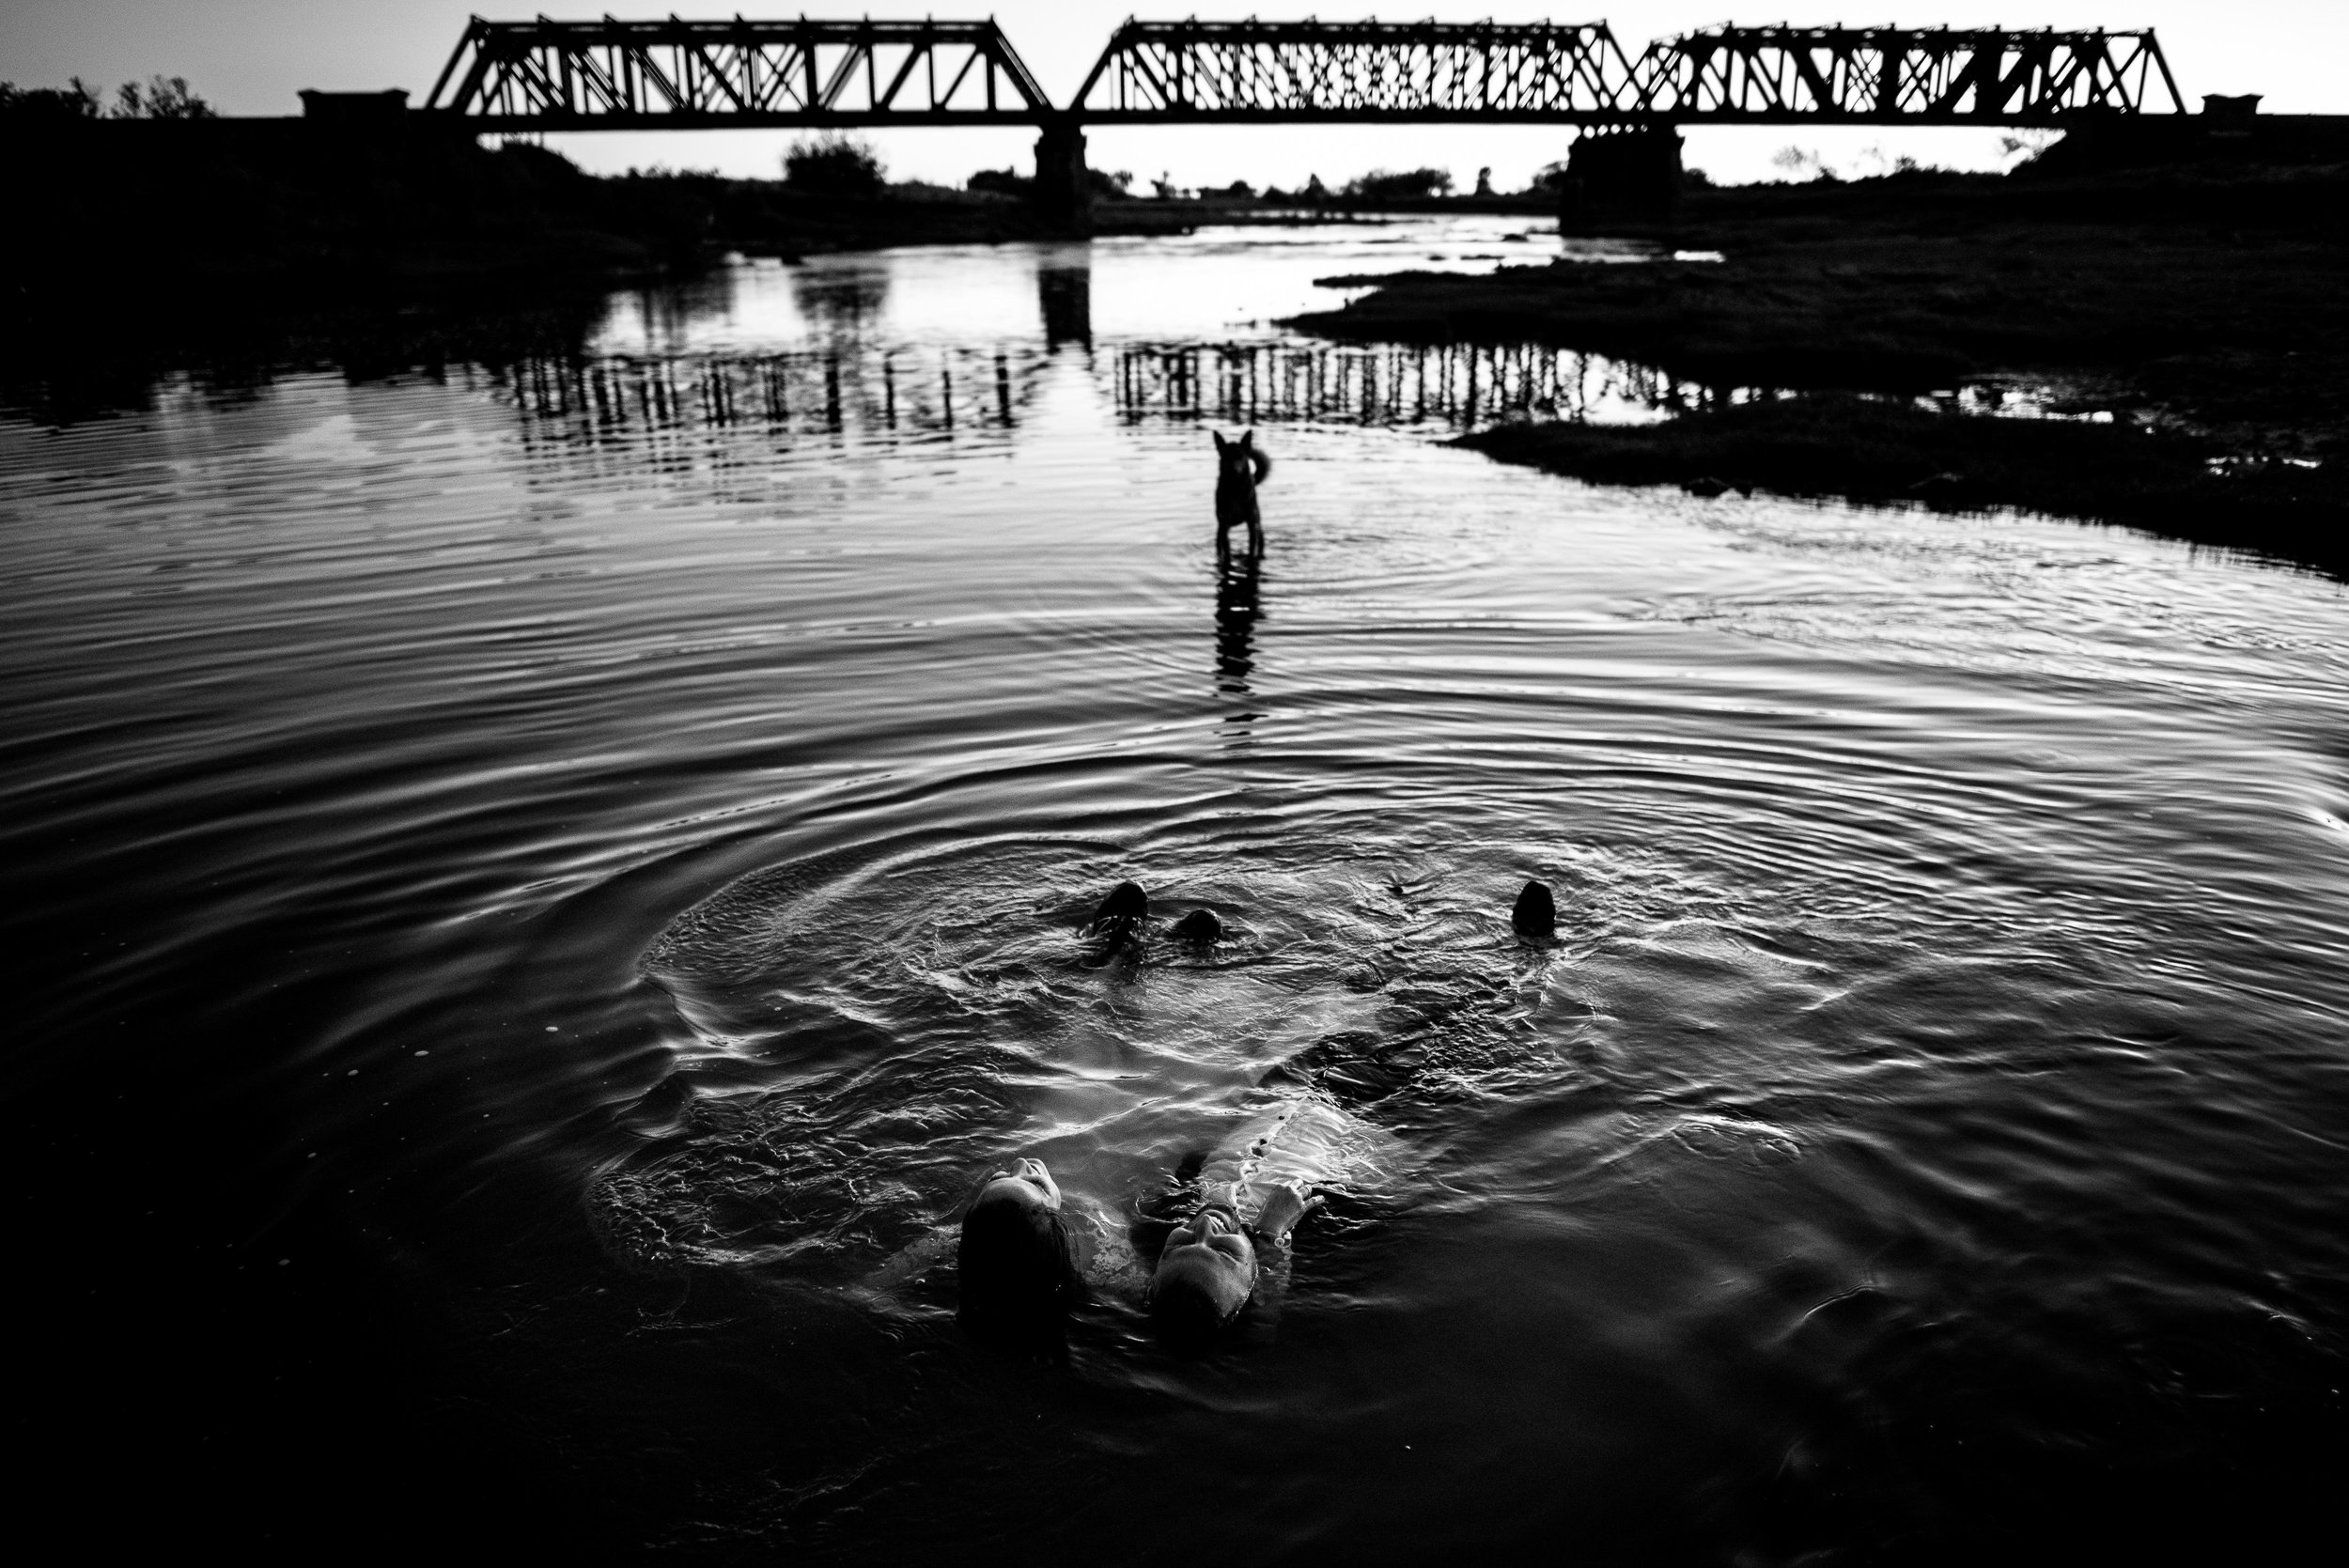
[[423, 16, 2185, 216]]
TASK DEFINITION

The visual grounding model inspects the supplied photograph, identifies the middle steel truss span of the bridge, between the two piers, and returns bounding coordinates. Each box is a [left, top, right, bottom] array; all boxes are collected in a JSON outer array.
[[1071, 19, 1630, 124]]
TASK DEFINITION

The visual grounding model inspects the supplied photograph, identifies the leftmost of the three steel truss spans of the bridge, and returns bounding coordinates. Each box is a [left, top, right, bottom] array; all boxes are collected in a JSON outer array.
[[426, 16, 1052, 132]]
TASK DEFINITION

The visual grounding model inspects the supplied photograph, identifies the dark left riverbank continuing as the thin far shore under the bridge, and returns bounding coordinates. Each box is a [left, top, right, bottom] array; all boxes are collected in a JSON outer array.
[[0, 115, 1539, 315]]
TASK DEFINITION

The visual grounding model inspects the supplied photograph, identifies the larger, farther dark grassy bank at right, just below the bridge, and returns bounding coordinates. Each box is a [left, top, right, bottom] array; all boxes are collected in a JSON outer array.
[[1295, 169, 2349, 458]]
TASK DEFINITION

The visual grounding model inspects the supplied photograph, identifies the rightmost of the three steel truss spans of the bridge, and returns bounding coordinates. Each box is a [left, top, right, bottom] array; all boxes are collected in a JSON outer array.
[[1628, 25, 2185, 127]]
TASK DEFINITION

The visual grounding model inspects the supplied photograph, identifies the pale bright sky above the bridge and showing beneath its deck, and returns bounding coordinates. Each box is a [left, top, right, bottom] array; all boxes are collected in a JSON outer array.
[[0, 0, 2349, 188]]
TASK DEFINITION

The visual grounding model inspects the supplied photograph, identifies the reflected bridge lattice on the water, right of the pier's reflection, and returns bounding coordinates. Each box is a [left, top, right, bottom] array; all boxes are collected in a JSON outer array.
[[1113, 343, 1736, 429]]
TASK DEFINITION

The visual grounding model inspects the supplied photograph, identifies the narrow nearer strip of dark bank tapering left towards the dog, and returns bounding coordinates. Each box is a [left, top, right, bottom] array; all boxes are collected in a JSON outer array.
[[1459, 392, 2349, 573]]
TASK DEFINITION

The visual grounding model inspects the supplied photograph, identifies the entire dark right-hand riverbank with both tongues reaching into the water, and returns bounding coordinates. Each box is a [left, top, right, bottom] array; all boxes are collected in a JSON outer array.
[[1292, 166, 2349, 566]]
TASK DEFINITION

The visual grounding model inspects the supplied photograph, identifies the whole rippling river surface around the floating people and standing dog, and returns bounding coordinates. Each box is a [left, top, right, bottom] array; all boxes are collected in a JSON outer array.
[[0, 221, 2349, 1563]]
